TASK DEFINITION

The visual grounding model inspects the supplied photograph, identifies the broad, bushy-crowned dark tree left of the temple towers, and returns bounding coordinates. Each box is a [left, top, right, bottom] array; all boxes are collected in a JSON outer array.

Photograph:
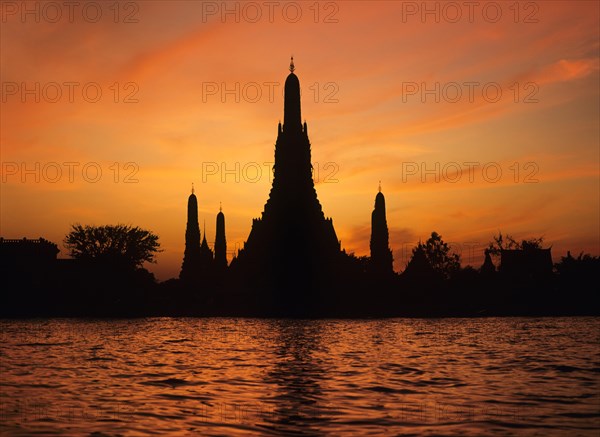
[[64, 224, 161, 269]]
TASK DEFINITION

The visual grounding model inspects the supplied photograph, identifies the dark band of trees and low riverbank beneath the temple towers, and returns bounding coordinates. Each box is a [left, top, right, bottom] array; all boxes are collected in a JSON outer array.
[[0, 225, 600, 317]]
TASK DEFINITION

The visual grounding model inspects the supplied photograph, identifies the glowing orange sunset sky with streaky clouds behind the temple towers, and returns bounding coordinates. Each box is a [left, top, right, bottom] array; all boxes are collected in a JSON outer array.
[[0, 1, 600, 279]]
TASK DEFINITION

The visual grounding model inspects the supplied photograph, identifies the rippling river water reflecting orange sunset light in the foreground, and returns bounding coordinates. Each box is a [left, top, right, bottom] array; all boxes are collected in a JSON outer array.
[[0, 318, 600, 436]]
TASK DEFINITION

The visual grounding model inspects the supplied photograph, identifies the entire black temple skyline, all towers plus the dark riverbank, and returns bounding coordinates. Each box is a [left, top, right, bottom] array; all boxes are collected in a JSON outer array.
[[0, 58, 600, 318]]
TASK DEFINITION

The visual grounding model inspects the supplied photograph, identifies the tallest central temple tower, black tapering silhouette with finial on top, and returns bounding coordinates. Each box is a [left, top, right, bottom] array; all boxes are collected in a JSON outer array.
[[231, 58, 342, 305]]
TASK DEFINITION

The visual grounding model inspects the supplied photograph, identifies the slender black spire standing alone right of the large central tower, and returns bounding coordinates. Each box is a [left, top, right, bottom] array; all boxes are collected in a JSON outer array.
[[369, 183, 394, 275]]
